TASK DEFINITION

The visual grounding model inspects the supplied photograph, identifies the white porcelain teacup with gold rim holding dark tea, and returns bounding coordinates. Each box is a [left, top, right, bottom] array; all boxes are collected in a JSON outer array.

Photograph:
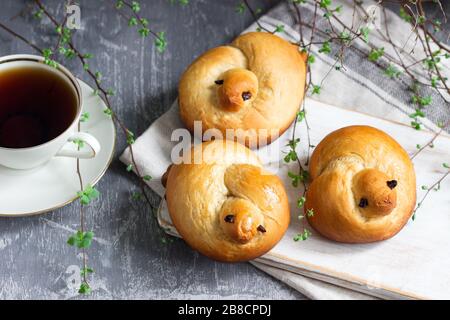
[[0, 55, 100, 170]]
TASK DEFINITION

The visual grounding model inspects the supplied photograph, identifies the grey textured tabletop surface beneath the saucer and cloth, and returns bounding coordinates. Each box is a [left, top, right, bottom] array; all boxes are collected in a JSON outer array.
[[0, 0, 310, 299]]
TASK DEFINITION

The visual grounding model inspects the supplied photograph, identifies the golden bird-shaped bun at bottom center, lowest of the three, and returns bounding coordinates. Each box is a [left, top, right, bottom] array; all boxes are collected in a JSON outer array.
[[166, 140, 289, 262]]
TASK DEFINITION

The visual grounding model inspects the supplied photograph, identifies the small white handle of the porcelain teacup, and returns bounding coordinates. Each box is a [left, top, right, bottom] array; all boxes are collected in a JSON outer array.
[[56, 132, 101, 159]]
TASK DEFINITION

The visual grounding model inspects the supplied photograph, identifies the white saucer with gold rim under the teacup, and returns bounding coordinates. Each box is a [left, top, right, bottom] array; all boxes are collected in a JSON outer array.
[[0, 80, 116, 217]]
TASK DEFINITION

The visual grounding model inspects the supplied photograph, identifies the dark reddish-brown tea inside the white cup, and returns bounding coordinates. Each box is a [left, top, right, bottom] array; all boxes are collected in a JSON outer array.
[[0, 66, 78, 149]]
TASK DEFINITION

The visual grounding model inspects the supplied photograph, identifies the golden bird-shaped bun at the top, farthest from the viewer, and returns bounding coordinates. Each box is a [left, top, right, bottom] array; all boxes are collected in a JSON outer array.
[[179, 32, 306, 147]]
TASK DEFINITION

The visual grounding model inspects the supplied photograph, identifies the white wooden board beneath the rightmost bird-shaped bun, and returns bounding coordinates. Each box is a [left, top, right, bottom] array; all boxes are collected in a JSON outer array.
[[160, 99, 450, 299]]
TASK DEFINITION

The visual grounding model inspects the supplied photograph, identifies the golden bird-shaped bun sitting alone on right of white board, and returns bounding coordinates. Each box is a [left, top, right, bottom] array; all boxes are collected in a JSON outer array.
[[305, 126, 416, 243]]
